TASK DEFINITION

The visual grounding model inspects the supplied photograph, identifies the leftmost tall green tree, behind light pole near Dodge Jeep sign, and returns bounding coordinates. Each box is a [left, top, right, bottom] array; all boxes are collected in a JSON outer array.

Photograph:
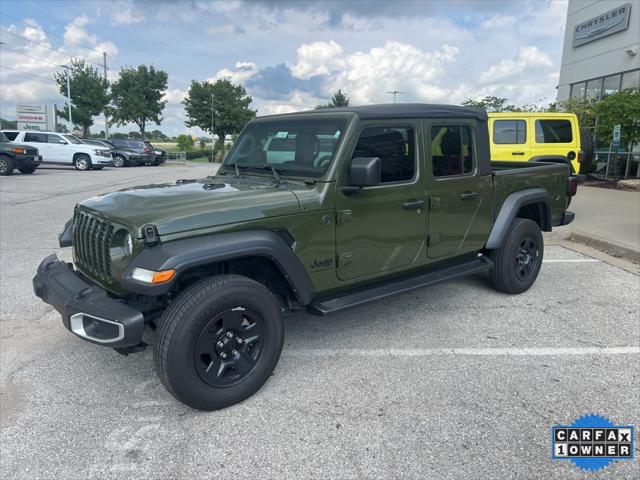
[[55, 59, 109, 137]]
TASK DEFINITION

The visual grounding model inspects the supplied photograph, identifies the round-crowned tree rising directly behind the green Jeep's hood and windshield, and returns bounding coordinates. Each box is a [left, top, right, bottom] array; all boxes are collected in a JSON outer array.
[[182, 80, 256, 160]]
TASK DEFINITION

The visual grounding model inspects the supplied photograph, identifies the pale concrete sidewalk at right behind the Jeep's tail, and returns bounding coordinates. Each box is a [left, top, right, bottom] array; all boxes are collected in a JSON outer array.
[[554, 186, 640, 262]]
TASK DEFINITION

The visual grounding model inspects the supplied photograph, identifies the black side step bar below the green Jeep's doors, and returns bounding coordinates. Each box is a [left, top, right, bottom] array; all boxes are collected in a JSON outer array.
[[307, 256, 493, 315]]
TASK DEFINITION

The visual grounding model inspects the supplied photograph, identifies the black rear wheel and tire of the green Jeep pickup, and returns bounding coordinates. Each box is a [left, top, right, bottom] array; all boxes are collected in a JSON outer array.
[[490, 218, 544, 294]]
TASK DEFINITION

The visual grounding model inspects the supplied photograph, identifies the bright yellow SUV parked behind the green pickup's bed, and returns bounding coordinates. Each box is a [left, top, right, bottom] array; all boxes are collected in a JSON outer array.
[[489, 112, 593, 175]]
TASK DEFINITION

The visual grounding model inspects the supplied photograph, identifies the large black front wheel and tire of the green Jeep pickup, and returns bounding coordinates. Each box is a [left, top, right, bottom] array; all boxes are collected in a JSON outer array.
[[154, 275, 284, 410]]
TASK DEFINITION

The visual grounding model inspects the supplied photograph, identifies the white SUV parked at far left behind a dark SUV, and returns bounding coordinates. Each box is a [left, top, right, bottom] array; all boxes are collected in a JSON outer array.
[[2, 130, 113, 170]]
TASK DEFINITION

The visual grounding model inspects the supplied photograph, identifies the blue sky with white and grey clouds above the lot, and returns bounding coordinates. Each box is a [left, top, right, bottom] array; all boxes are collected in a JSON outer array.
[[0, 0, 567, 136]]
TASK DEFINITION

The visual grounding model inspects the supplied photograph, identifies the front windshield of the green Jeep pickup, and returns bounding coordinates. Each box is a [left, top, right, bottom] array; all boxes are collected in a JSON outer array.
[[224, 119, 345, 178]]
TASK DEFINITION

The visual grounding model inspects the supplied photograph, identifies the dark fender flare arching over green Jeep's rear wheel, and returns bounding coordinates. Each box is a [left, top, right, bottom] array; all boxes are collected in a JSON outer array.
[[486, 188, 551, 249]]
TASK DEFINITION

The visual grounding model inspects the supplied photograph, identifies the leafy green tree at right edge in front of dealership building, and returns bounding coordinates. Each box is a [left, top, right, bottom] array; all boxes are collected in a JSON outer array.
[[595, 89, 640, 147]]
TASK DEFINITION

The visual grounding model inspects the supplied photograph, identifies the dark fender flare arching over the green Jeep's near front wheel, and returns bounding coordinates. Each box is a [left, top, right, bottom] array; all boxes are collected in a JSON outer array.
[[122, 230, 314, 305]]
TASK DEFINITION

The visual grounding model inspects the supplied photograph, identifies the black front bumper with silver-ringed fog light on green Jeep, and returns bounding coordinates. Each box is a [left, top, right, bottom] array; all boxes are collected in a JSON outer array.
[[33, 254, 144, 348]]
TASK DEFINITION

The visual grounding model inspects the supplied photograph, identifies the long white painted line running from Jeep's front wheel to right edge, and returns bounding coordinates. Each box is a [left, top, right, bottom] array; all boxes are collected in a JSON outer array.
[[282, 346, 640, 357]]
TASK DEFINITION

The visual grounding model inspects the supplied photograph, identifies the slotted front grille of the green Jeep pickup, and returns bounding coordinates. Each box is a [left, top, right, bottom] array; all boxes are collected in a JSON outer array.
[[73, 209, 114, 280]]
